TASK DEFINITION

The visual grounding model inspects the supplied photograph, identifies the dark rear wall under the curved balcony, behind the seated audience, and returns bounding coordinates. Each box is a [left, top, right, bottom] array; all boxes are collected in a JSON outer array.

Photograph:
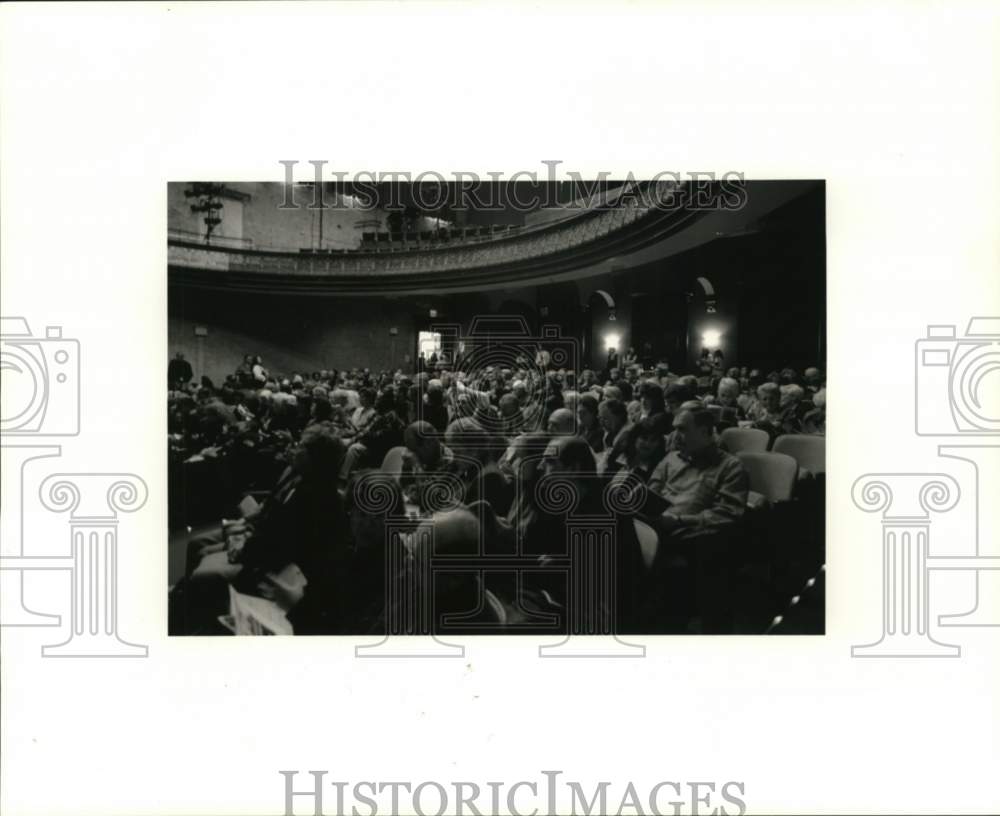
[[169, 186, 826, 380]]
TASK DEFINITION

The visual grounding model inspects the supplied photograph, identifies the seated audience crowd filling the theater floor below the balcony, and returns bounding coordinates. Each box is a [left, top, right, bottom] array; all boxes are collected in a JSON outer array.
[[168, 344, 826, 634]]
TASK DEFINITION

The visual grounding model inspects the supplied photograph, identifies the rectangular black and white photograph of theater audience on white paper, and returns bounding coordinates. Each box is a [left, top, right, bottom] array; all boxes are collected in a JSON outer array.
[[167, 178, 827, 636]]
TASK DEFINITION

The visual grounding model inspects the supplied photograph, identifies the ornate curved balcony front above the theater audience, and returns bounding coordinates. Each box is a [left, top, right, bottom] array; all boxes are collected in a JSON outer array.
[[168, 182, 704, 294]]
